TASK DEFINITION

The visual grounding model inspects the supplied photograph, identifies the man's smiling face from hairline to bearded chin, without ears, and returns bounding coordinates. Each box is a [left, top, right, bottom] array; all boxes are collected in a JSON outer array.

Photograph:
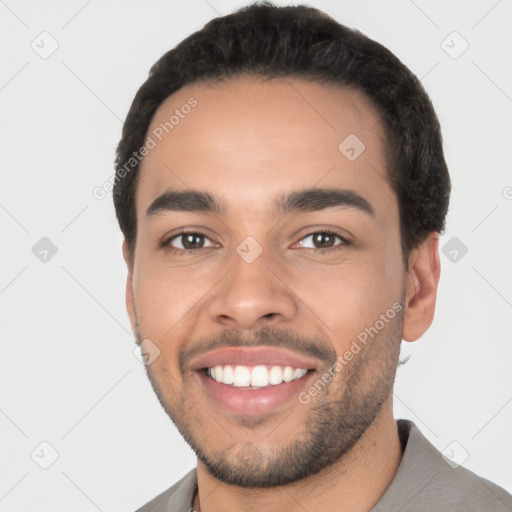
[[128, 78, 405, 486]]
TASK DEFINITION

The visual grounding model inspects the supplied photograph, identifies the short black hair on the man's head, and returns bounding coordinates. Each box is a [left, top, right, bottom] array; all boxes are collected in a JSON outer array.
[[113, 2, 451, 266]]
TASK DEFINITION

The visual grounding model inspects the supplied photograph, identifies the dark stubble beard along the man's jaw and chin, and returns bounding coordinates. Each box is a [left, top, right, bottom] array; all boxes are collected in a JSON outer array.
[[137, 313, 403, 488]]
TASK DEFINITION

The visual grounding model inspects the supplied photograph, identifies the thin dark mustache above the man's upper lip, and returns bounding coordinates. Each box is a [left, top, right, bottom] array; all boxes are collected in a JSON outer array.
[[178, 327, 337, 376]]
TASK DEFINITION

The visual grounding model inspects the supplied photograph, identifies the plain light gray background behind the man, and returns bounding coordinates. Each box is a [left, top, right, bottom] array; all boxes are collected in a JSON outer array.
[[0, 0, 512, 512]]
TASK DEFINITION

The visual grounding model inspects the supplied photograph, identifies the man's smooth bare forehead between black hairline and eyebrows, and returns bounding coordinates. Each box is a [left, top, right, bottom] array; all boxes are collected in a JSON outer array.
[[136, 77, 394, 216]]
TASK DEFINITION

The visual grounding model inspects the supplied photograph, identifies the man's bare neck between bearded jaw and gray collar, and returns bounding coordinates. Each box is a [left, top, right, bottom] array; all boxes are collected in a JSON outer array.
[[194, 397, 402, 512]]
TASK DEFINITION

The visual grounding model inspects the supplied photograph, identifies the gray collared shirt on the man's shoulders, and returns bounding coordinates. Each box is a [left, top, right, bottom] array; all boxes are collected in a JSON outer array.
[[137, 420, 512, 512]]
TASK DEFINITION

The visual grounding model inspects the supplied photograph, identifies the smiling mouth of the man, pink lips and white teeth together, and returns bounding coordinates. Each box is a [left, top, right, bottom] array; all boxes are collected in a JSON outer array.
[[193, 346, 317, 416]]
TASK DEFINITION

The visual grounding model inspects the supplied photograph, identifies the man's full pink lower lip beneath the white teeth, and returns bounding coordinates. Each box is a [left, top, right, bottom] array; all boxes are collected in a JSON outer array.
[[197, 371, 315, 416]]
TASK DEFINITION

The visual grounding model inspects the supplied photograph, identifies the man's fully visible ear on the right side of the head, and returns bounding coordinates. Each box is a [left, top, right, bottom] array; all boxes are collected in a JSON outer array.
[[402, 233, 441, 341]]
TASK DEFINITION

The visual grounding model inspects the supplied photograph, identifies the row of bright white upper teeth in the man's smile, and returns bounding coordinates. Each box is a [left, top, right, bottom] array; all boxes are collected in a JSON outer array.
[[207, 365, 308, 388]]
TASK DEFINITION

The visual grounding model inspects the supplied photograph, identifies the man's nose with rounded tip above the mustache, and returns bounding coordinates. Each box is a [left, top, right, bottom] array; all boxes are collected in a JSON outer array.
[[209, 246, 297, 329]]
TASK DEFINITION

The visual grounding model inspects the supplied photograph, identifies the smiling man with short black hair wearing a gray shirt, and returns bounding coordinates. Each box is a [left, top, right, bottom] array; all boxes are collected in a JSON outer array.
[[114, 4, 512, 512]]
